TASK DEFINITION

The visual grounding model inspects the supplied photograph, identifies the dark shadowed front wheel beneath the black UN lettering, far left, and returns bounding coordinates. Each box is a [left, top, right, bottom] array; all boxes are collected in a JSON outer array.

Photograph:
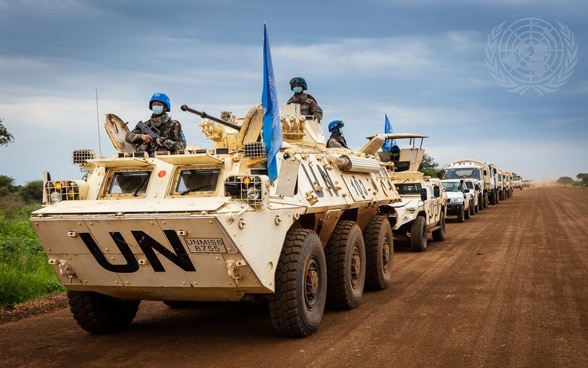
[[67, 291, 141, 334]]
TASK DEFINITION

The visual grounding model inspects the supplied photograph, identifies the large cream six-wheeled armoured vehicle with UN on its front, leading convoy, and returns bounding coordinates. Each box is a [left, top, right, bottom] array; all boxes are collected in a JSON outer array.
[[31, 105, 400, 337]]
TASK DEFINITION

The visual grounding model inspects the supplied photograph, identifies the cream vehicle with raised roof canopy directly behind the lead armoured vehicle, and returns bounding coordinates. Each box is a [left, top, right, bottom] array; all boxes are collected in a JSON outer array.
[[362, 133, 447, 252]]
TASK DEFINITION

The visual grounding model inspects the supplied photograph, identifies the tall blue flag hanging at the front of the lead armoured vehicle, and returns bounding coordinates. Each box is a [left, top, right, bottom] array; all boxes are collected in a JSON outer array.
[[261, 23, 282, 183]]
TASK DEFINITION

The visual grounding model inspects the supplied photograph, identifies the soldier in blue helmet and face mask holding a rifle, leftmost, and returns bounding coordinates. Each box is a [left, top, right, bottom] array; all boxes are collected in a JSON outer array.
[[125, 93, 186, 155]]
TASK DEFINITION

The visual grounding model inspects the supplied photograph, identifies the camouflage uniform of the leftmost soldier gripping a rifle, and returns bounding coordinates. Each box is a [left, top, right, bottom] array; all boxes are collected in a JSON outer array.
[[125, 113, 186, 155]]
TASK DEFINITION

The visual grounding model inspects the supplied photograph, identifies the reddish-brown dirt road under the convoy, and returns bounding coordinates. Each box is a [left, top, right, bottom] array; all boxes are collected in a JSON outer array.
[[0, 187, 588, 368]]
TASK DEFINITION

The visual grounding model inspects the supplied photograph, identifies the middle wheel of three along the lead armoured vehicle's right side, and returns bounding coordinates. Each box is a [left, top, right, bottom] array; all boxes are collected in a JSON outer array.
[[325, 221, 366, 309]]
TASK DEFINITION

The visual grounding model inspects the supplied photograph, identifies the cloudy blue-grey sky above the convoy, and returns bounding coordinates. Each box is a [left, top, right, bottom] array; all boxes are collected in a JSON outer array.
[[0, 0, 588, 185]]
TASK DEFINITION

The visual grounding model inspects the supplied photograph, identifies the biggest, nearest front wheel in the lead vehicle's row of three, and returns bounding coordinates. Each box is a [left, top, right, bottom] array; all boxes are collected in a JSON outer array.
[[268, 228, 327, 337]]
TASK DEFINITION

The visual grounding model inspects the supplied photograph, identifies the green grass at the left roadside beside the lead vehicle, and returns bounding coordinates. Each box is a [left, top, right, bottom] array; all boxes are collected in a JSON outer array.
[[0, 206, 65, 309]]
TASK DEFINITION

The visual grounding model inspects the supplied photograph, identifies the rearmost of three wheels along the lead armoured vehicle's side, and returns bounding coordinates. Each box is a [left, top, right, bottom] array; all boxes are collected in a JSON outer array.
[[363, 215, 394, 290]]
